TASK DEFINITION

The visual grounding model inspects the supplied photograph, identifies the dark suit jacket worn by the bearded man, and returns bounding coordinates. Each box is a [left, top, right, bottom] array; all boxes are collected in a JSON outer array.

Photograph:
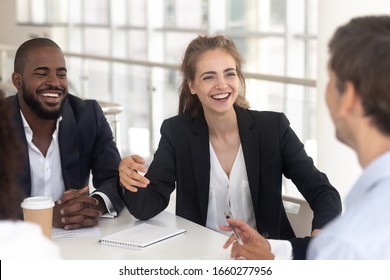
[[7, 94, 123, 213]]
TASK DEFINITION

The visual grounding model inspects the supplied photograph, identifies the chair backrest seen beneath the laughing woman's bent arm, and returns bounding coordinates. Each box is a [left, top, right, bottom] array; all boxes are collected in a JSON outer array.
[[282, 195, 313, 237]]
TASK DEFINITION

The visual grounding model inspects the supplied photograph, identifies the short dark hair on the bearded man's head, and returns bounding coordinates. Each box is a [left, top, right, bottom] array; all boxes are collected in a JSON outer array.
[[14, 38, 61, 74]]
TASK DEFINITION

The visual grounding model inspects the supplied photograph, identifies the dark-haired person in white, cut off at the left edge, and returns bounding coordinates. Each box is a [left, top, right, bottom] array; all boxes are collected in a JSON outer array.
[[0, 89, 61, 261]]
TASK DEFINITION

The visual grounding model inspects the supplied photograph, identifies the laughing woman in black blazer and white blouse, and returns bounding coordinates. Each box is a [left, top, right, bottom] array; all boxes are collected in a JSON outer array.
[[119, 35, 341, 243]]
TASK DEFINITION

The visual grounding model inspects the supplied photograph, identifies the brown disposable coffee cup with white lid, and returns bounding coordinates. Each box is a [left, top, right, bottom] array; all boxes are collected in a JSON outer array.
[[21, 196, 54, 239]]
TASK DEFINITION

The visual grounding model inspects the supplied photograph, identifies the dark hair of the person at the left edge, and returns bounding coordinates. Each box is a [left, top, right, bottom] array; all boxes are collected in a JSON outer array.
[[0, 89, 21, 220]]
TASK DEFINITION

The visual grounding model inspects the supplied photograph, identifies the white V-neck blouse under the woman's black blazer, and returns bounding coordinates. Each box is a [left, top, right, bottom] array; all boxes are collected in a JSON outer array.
[[206, 143, 256, 235]]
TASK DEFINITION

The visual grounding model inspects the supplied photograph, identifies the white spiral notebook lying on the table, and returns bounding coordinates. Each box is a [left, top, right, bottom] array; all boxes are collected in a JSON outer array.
[[100, 223, 186, 249]]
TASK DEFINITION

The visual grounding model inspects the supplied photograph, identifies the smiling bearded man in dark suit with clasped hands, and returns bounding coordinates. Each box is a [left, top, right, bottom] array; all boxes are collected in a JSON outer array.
[[6, 38, 123, 229]]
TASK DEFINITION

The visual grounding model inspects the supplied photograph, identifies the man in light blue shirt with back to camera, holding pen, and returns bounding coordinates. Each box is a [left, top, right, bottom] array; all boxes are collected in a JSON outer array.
[[221, 16, 390, 260]]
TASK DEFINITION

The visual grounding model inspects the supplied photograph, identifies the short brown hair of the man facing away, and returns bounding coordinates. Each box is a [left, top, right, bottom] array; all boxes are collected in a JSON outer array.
[[329, 16, 390, 135]]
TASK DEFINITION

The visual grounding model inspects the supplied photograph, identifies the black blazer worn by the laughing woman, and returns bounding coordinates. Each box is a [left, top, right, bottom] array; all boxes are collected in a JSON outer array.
[[123, 107, 341, 239]]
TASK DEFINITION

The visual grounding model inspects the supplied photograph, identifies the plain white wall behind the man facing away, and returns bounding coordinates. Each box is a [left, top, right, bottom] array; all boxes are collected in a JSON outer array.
[[317, 0, 390, 201]]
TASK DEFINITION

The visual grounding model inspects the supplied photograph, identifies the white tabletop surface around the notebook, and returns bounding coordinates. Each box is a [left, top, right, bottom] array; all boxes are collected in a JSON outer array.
[[53, 209, 230, 260]]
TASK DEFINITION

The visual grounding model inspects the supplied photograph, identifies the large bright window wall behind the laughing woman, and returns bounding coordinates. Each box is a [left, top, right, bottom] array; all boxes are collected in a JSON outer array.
[[17, 0, 317, 197]]
